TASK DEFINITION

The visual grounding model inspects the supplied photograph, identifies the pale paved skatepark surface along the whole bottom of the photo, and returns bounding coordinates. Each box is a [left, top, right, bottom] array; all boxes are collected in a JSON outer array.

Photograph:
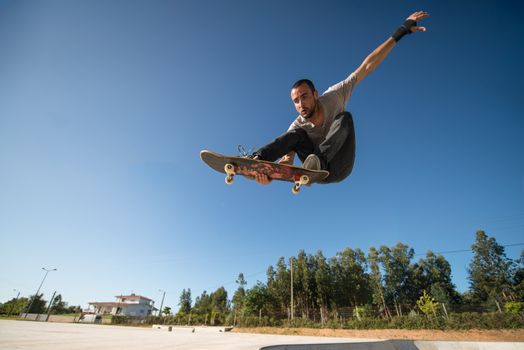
[[0, 320, 524, 350]]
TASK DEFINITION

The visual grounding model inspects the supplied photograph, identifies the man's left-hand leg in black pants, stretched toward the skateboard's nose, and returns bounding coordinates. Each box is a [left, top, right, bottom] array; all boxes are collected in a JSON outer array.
[[253, 129, 315, 162]]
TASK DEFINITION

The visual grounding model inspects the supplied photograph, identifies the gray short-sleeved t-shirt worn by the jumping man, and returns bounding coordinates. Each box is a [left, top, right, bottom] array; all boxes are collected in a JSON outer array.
[[288, 73, 357, 147]]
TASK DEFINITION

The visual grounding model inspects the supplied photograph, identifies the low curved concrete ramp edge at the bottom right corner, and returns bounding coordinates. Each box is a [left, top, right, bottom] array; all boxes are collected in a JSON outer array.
[[260, 340, 524, 350]]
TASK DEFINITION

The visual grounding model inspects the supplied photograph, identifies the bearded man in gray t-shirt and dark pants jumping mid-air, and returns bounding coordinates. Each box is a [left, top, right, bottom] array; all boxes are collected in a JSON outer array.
[[250, 11, 429, 185]]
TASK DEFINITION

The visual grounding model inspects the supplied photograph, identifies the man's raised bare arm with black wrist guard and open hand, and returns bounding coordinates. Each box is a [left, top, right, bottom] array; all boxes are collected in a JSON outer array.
[[354, 11, 429, 84]]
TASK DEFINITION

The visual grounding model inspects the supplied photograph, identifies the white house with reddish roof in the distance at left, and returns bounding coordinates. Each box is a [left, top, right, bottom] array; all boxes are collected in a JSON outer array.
[[89, 294, 157, 316]]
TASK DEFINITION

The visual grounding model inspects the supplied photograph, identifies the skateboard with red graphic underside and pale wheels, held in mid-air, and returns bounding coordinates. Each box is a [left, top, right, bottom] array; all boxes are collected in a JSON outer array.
[[200, 150, 329, 194]]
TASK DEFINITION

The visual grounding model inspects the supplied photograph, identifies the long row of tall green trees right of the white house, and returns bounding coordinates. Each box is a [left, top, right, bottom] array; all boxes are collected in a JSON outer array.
[[166, 231, 524, 325]]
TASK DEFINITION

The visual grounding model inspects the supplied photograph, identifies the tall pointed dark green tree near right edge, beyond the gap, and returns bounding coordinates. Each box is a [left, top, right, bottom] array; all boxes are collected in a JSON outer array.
[[468, 230, 514, 312]]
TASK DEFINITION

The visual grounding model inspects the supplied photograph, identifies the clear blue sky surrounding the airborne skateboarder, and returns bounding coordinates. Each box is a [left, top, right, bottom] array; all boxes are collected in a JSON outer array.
[[0, 0, 524, 308]]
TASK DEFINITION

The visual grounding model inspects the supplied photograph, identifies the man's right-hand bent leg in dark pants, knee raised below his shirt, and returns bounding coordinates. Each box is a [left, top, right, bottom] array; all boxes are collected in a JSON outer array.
[[318, 112, 355, 183]]
